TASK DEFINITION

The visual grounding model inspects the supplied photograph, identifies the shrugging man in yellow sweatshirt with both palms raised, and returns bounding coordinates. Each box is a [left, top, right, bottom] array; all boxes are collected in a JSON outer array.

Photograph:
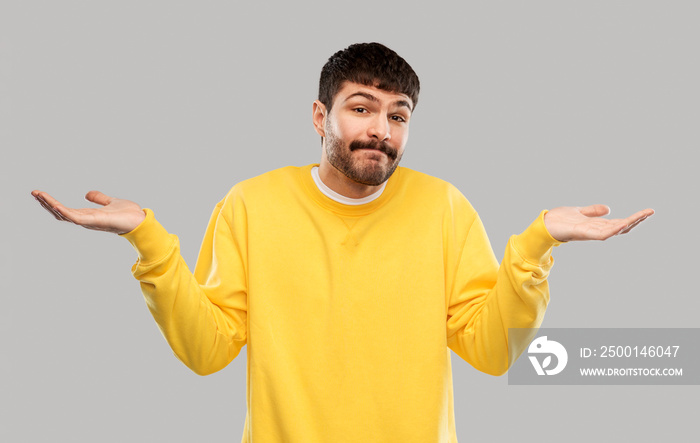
[[32, 43, 653, 443]]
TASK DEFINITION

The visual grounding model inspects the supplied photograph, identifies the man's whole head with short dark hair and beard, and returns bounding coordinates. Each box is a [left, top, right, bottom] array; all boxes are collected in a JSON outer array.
[[314, 43, 420, 190]]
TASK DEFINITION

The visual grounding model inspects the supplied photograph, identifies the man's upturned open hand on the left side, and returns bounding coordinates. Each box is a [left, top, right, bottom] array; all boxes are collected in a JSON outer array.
[[32, 191, 146, 234]]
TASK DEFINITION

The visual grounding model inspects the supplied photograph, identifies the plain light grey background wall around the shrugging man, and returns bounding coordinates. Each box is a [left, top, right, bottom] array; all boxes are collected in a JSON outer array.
[[0, 0, 700, 442]]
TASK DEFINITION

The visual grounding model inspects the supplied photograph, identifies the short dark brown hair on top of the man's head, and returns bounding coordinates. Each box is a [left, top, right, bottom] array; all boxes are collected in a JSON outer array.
[[318, 43, 420, 112]]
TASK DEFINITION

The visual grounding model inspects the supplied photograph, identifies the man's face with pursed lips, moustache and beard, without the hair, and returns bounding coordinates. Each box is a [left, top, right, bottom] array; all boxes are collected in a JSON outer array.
[[324, 82, 413, 186]]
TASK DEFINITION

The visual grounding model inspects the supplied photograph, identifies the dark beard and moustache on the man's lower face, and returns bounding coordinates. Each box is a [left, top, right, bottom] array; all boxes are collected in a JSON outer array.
[[326, 127, 403, 186]]
